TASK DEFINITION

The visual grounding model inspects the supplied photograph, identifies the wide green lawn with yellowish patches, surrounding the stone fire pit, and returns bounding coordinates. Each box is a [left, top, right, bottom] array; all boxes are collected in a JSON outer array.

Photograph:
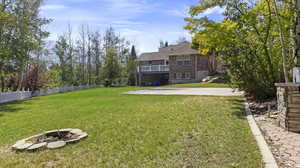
[[0, 87, 262, 168]]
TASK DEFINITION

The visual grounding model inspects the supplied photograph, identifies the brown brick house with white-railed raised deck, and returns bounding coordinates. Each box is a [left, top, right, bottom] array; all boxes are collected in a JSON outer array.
[[138, 42, 217, 86]]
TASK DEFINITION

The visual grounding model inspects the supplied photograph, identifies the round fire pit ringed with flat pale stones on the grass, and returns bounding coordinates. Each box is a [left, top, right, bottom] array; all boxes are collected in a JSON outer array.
[[12, 128, 88, 151]]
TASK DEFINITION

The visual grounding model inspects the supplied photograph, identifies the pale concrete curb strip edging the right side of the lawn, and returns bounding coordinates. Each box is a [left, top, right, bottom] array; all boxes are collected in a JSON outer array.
[[244, 99, 278, 168]]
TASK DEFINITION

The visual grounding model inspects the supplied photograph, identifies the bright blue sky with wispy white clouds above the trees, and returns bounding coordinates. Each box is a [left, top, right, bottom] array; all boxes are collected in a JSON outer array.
[[41, 0, 223, 53]]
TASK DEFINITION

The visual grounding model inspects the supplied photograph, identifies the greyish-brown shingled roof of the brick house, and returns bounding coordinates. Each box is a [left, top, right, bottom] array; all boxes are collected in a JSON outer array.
[[138, 42, 199, 61]]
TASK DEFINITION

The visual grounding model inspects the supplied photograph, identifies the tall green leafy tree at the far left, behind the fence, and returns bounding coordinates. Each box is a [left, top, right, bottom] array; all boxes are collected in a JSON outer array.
[[0, 0, 50, 89]]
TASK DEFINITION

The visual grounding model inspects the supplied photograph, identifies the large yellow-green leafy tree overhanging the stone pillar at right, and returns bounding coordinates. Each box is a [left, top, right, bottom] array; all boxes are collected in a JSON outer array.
[[185, 0, 295, 99]]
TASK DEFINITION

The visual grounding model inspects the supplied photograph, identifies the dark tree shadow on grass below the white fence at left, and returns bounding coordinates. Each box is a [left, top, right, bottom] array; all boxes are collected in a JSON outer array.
[[0, 100, 28, 117]]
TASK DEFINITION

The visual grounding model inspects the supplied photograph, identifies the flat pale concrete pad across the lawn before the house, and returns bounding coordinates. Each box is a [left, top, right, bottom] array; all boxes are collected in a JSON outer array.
[[126, 88, 244, 96]]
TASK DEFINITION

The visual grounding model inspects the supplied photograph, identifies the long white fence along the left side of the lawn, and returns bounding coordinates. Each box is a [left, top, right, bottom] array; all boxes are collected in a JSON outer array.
[[0, 85, 103, 104]]
